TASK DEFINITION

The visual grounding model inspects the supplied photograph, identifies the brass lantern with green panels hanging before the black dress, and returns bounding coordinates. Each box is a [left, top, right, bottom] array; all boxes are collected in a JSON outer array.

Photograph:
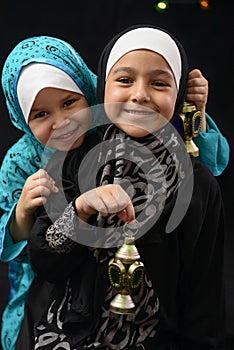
[[108, 230, 144, 314]]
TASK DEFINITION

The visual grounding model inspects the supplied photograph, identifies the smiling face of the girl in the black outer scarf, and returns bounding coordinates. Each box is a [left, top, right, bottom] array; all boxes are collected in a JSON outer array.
[[104, 49, 177, 137]]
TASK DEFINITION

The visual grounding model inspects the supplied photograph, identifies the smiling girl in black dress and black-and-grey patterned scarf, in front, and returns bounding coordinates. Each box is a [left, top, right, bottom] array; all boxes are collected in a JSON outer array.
[[28, 25, 225, 350]]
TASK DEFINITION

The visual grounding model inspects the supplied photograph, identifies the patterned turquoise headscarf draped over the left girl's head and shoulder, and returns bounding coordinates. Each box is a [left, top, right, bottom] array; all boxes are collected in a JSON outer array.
[[0, 36, 97, 223]]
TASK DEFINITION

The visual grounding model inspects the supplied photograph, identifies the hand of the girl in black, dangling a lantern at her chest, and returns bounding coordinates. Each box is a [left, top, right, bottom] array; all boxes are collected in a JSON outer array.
[[75, 184, 135, 222]]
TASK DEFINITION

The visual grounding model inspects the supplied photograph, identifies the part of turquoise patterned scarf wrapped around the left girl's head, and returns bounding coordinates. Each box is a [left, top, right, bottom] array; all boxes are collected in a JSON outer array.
[[2, 36, 97, 134]]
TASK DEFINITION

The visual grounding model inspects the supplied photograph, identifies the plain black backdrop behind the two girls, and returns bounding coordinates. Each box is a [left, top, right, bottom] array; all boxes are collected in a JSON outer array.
[[0, 0, 234, 349]]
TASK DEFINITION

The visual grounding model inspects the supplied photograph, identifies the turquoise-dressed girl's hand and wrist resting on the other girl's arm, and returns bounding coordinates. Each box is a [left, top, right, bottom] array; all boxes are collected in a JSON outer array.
[[10, 169, 58, 242]]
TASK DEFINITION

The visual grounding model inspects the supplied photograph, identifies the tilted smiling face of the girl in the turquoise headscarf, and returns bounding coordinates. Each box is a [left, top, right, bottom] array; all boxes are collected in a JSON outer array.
[[28, 88, 91, 151]]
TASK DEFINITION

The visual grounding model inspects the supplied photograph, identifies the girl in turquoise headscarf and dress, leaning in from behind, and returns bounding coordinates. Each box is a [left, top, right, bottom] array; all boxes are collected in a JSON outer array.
[[0, 36, 97, 350]]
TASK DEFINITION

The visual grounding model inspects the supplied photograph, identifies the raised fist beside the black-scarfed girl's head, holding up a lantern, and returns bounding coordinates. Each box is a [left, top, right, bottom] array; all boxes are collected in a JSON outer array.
[[186, 69, 208, 131]]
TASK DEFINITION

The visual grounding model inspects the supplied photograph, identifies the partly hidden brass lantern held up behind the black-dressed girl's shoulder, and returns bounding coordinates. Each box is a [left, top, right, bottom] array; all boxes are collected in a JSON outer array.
[[179, 101, 202, 157]]
